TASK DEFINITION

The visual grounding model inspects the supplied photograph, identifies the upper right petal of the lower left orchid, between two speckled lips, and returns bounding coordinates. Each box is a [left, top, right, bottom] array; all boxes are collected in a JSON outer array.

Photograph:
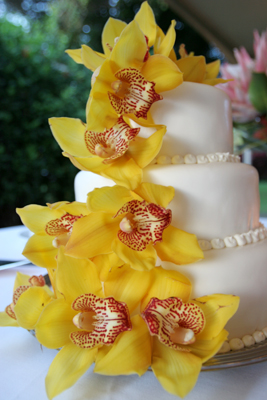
[[104, 265, 151, 313]]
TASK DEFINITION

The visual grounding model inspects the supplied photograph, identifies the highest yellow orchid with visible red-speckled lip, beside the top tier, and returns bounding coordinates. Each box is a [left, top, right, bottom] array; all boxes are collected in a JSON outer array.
[[89, 20, 183, 131]]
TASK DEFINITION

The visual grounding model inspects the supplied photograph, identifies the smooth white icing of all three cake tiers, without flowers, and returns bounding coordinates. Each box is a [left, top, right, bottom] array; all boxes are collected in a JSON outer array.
[[75, 82, 267, 339]]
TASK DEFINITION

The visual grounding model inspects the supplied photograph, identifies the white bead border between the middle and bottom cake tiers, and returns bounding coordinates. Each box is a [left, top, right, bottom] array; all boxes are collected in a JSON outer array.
[[198, 224, 267, 251]]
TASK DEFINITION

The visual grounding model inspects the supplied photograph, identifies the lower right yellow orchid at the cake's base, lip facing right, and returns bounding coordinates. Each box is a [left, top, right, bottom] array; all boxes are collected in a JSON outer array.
[[94, 267, 239, 397]]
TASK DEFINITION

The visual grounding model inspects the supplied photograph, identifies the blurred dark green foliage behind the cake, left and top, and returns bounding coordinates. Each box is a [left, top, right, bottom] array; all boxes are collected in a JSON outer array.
[[0, 0, 217, 227]]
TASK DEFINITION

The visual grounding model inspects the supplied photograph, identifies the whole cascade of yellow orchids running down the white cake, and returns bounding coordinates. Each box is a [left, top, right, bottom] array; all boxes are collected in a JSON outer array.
[[0, 2, 239, 399]]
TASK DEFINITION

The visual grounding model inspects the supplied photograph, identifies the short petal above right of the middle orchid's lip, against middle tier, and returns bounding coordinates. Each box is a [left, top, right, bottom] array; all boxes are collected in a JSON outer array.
[[135, 182, 175, 208]]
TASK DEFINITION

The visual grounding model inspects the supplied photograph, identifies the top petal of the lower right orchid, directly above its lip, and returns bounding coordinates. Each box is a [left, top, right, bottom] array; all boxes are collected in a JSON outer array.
[[141, 267, 192, 310]]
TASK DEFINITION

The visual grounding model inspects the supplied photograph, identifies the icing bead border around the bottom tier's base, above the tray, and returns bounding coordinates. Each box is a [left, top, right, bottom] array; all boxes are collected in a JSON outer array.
[[218, 327, 267, 354]]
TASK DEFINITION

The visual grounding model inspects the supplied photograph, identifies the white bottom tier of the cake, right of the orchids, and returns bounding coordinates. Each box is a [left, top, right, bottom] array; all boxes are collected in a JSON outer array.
[[162, 239, 267, 339]]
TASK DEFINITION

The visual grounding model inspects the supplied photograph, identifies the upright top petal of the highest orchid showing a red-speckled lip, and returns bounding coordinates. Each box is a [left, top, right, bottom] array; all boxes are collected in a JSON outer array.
[[110, 20, 147, 73]]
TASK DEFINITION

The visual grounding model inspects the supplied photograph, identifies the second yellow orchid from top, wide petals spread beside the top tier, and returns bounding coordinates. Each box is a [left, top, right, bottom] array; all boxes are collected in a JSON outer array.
[[49, 117, 166, 189]]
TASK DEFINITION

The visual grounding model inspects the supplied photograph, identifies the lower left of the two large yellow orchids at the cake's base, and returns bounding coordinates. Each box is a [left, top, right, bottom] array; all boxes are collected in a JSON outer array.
[[35, 248, 151, 399]]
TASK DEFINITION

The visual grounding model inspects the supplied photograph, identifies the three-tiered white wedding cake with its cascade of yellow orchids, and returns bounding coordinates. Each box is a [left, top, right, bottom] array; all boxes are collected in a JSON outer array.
[[0, 2, 267, 399]]
